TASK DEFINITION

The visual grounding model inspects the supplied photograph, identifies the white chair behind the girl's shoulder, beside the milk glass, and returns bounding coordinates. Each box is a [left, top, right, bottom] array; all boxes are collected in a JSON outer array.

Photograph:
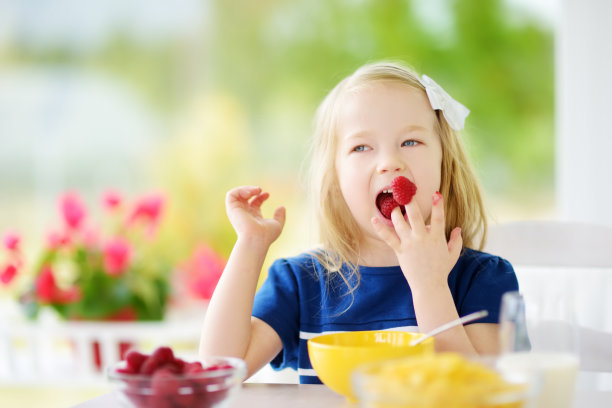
[[485, 221, 612, 389]]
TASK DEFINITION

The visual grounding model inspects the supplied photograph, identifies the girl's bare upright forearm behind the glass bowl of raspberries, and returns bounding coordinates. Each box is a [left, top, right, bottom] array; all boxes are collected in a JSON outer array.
[[200, 239, 269, 358]]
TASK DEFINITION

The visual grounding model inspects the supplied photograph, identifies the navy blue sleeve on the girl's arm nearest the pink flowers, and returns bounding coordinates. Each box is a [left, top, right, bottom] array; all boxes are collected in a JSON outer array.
[[252, 259, 299, 370]]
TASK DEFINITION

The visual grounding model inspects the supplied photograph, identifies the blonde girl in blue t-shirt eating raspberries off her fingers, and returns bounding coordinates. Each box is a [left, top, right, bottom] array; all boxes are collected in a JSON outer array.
[[200, 59, 518, 383]]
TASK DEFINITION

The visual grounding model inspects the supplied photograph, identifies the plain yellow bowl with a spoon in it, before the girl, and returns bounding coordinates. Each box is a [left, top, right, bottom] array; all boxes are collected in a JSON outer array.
[[308, 330, 434, 401]]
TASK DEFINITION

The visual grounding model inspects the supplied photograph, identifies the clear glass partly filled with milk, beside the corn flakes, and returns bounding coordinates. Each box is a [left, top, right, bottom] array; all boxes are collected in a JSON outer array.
[[498, 291, 579, 408]]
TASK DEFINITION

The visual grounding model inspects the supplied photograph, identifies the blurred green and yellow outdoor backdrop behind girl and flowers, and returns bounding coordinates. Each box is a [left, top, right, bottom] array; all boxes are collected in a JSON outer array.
[[0, 0, 556, 404]]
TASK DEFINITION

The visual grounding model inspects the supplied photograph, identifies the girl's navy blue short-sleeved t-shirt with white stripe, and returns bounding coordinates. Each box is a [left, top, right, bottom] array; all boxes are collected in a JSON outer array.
[[253, 248, 518, 384]]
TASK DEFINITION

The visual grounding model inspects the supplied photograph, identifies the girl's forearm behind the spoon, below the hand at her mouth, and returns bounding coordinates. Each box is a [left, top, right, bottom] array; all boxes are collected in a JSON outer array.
[[412, 285, 477, 354]]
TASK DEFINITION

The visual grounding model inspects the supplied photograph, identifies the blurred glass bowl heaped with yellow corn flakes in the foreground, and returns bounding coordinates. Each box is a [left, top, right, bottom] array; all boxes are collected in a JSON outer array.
[[352, 353, 537, 408]]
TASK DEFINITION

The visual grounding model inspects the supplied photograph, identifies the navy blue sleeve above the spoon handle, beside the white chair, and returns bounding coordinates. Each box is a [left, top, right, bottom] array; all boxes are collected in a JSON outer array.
[[457, 254, 518, 324]]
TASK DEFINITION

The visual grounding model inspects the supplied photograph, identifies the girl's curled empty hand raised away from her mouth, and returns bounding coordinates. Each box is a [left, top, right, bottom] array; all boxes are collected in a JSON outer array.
[[225, 186, 285, 246]]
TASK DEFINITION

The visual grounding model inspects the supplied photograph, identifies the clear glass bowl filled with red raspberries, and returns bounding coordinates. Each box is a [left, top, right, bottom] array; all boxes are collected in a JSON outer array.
[[107, 347, 246, 408]]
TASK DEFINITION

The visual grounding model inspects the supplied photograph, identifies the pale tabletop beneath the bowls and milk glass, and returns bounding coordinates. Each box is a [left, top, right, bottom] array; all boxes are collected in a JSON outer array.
[[74, 383, 612, 408]]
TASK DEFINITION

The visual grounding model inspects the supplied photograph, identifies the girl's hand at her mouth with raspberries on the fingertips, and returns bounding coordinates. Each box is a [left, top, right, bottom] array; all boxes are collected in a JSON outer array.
[[372, 192, 463, 291]]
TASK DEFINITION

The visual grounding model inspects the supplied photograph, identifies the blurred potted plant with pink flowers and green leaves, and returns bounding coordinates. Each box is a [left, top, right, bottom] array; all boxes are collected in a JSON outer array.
[[0, 192, 172, 367]]
